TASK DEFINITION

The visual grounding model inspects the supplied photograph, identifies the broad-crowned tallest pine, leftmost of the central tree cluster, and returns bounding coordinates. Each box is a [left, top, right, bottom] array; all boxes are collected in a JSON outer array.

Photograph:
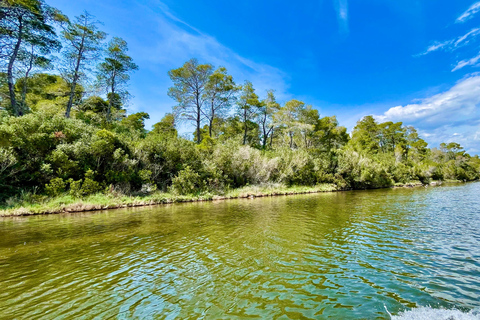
[[168, 59, 213, 144]]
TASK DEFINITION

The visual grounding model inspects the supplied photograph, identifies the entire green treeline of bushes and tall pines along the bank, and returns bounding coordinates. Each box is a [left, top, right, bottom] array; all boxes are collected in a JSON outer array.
[[0, 0, 480, 201]]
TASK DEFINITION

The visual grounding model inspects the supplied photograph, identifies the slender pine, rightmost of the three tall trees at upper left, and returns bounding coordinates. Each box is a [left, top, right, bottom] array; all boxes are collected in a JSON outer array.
[[97, 37, 138, 121]]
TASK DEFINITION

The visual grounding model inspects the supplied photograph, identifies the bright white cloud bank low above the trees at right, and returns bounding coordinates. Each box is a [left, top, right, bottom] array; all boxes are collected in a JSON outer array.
[[375, 74, 480, 152]]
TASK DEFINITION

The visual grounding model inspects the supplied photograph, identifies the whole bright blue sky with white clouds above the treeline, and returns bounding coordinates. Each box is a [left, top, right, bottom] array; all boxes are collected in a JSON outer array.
[[47, 0, 480, 154]]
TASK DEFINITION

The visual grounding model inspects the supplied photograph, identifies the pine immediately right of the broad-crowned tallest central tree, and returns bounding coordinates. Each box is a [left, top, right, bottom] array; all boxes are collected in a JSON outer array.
[[205, 67, 238, 137]]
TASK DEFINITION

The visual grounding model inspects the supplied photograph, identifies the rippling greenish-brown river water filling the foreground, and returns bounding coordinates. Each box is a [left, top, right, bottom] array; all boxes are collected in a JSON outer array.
[[0, 183, 480, 319]]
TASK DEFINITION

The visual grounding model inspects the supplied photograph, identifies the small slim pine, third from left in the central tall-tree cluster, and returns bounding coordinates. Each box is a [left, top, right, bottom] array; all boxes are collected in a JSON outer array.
[[237, 81, 260, 145]]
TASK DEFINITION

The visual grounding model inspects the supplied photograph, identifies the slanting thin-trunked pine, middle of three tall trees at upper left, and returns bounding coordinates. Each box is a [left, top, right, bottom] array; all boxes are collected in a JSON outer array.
[[62, 11, 106, 118]]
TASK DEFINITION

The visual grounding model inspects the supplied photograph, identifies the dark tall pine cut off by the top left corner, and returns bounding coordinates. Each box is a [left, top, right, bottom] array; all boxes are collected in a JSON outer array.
[[0, 0, 62, 116]]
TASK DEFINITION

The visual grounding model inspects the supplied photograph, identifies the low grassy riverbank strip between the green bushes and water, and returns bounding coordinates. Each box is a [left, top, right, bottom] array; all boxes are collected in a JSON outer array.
[[0, 180, 461, 217]]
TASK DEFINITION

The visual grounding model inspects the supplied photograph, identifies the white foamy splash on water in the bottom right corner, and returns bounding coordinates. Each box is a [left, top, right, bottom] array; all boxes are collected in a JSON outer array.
[[391, 307, 480, 320]]
